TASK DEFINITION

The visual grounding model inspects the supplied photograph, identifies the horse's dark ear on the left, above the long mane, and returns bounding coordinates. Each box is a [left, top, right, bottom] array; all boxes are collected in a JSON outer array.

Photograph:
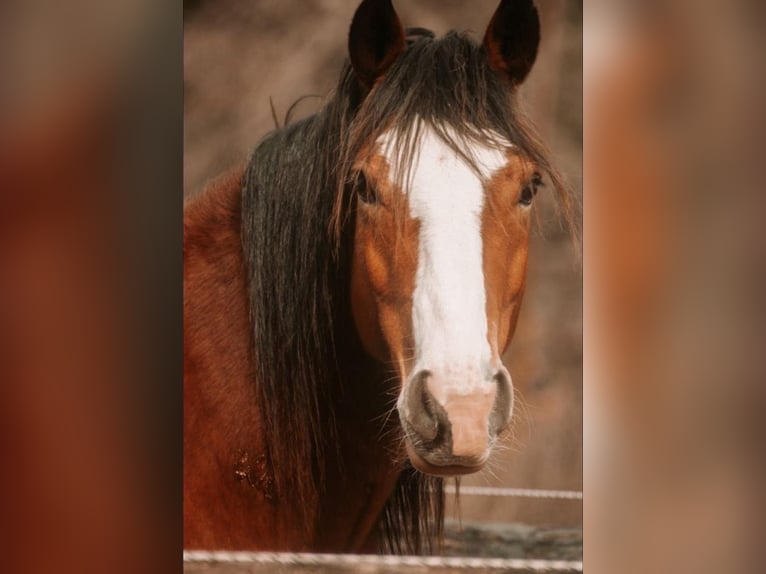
[[348, 0, 405, 90]]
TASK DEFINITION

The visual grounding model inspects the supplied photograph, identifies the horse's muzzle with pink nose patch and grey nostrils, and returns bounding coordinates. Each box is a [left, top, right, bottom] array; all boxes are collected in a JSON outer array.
[[399, 367, 513, 476]]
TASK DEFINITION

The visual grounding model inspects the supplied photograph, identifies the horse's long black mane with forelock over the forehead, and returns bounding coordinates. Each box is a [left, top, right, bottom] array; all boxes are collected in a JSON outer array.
[[242, 29, 568, 552]]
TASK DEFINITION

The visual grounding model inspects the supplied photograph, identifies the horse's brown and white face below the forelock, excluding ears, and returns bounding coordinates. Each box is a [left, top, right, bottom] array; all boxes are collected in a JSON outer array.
[[351, 128, 538, 474]]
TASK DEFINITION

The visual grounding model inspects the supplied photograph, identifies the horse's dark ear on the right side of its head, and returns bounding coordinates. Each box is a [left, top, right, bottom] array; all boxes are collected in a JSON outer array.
[[484, 0, 540, 86]]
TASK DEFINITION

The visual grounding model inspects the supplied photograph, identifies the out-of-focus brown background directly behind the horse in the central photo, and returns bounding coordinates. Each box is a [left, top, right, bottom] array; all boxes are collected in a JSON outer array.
[[184, 0, 582, 559]]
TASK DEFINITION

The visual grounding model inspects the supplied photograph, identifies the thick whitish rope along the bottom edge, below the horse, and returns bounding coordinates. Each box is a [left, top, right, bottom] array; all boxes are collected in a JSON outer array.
[[184, 550, 582, 572]]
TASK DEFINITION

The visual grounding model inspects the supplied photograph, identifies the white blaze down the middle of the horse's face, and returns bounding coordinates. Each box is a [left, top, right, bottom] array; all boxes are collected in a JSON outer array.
[[381, 123, 507, 392]]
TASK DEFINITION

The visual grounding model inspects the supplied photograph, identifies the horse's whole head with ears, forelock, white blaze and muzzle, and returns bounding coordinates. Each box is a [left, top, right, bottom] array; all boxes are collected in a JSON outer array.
[[348, 0, 546, 475]]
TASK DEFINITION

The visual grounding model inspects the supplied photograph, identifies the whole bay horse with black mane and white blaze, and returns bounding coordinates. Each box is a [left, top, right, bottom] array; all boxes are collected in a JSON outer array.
[[184, 0, 570, 553]]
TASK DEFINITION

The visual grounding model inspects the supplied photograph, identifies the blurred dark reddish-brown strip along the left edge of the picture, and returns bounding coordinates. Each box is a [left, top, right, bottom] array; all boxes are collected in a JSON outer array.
[[0, 0, 183, 574]]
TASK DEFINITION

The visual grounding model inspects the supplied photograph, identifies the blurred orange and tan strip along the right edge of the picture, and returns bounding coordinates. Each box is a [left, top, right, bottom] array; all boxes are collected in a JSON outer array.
[[584, 0, 766, 574]]
